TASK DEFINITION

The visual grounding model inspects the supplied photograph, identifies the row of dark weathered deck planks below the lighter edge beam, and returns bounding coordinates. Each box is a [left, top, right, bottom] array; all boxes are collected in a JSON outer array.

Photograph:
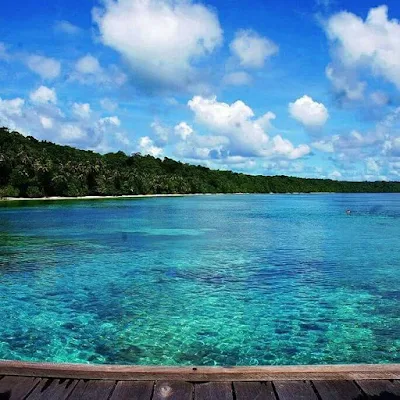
[[0, 376, 400, 400]]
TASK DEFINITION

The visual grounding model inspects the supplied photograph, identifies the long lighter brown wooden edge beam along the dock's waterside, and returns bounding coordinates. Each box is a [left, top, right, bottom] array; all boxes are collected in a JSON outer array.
[[0, 361, 400, 382]]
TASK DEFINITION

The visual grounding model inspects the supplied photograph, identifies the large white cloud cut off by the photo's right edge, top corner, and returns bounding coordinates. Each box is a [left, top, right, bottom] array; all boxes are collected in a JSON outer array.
[[325, 5, 400, 89]]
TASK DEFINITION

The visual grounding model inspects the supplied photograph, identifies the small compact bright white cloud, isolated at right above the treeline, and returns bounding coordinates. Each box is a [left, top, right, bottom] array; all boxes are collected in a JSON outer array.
[[289, 95, 329, 128]]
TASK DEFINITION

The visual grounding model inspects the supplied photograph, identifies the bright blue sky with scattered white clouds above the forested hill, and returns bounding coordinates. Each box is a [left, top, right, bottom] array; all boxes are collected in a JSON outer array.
[[0, 0, 400, 181]]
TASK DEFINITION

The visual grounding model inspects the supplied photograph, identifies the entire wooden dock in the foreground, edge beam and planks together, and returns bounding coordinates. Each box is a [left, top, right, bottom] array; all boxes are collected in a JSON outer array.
[[0, 361, 400, 400]]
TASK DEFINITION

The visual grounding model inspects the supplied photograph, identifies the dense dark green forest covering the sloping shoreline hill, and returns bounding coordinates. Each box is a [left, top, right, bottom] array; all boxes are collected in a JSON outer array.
[[0, 128, 400, 197]]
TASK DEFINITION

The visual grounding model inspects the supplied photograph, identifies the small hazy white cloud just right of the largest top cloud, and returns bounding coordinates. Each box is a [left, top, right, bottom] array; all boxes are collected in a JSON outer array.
[[229, 29, 279, 68]]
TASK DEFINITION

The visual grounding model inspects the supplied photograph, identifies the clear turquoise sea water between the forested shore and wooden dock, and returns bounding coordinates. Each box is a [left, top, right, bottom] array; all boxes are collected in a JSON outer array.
[[0, 194, 400, 365]]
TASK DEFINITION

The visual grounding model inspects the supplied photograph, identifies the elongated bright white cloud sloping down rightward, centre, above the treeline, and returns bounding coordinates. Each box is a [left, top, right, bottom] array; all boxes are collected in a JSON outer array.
[[188, 96, 310, 158]]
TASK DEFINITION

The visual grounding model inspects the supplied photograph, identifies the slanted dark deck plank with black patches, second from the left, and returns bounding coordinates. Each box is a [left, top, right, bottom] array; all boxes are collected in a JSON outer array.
[[27, 379, 78, 400]]
